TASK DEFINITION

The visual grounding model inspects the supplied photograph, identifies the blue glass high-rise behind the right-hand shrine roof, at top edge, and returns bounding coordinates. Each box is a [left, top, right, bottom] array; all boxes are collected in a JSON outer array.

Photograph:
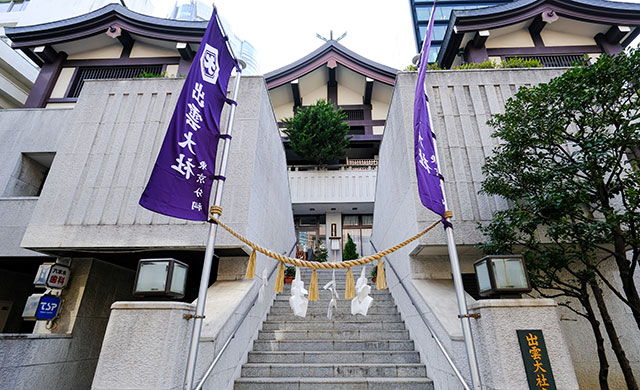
[[409, 0, 512, 62]]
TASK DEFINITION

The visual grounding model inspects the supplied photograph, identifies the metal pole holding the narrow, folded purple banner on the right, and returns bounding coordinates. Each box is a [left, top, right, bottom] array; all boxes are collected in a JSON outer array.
[[427, 100, 482, 390]]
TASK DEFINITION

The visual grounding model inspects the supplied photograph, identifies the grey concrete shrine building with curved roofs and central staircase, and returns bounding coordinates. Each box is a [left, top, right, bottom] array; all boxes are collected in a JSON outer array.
[[0, 0, 640, 390]]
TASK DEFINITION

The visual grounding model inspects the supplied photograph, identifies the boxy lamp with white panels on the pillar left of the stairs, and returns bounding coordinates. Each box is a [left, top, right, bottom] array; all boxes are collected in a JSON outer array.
[[133, 258, 189, 299]]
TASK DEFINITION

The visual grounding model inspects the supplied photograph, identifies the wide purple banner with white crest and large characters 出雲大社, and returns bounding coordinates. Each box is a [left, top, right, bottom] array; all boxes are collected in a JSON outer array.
[[140, 8, 237, 221]]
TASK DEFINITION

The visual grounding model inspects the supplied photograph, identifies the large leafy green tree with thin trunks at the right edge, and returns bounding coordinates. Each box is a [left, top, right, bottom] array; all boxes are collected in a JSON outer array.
[[483, 50, 640, 389]]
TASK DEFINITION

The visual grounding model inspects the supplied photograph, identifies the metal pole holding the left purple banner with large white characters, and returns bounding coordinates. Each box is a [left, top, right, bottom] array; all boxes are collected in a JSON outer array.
[[184, 72, 245, 390]]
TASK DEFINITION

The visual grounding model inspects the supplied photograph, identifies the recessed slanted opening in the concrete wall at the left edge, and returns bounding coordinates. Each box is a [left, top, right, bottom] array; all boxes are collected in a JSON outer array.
[[2, 153, 55, 197]]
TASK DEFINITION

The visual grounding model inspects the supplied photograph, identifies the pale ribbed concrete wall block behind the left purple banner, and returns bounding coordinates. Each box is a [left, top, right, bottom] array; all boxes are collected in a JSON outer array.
[[22, 77, 293, 256]]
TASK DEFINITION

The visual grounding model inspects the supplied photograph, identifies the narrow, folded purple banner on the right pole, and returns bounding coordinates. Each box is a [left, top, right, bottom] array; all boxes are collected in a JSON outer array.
[[413, 3, 445, 220]]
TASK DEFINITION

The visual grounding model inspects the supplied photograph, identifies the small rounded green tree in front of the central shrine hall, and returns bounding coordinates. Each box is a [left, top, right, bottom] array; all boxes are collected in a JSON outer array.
[[283, 99, 351, 165]]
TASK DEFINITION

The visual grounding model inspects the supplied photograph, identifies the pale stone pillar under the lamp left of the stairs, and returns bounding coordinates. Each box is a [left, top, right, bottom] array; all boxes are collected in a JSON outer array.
[[91, 302, 195, 390]]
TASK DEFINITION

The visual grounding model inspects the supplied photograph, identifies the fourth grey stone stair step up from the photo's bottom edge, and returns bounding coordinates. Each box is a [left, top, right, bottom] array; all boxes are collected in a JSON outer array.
[[253, 340, 414, 352]]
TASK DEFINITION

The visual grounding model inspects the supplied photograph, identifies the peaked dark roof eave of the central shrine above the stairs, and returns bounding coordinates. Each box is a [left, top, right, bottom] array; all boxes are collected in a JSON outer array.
[[265, 40, 398, 89]]
